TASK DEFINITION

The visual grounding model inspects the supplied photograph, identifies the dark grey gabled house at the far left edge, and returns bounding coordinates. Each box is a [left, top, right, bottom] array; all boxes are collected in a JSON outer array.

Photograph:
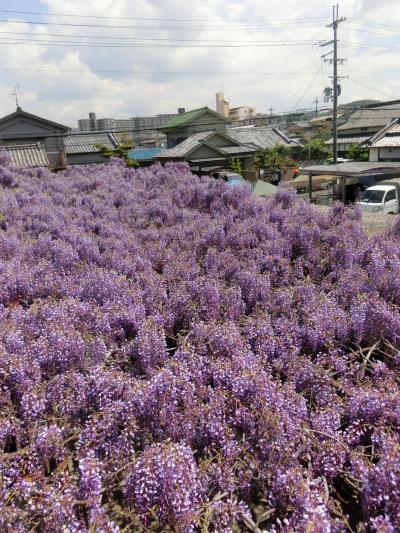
[[0, 107, 70, 169]]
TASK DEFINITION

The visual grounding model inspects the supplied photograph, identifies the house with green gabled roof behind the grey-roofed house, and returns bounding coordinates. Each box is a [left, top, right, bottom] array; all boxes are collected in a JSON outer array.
[[158, 107, 230, 148]]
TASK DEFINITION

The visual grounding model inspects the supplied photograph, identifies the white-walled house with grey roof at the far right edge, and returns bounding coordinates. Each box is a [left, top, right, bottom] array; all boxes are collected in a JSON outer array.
[[362, 118, 400, 161]]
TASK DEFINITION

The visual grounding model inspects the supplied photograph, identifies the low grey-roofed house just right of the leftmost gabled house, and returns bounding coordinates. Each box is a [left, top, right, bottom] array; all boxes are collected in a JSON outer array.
[[64, 132, 119, 165]]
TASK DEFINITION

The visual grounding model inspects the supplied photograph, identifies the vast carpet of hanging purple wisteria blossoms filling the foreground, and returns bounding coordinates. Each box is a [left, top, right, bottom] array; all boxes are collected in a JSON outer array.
[[0, 158, 400, 533]]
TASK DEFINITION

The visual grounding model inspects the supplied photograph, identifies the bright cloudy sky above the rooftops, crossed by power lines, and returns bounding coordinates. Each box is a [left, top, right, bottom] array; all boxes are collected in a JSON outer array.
[[0, 0, 400, 127]]
